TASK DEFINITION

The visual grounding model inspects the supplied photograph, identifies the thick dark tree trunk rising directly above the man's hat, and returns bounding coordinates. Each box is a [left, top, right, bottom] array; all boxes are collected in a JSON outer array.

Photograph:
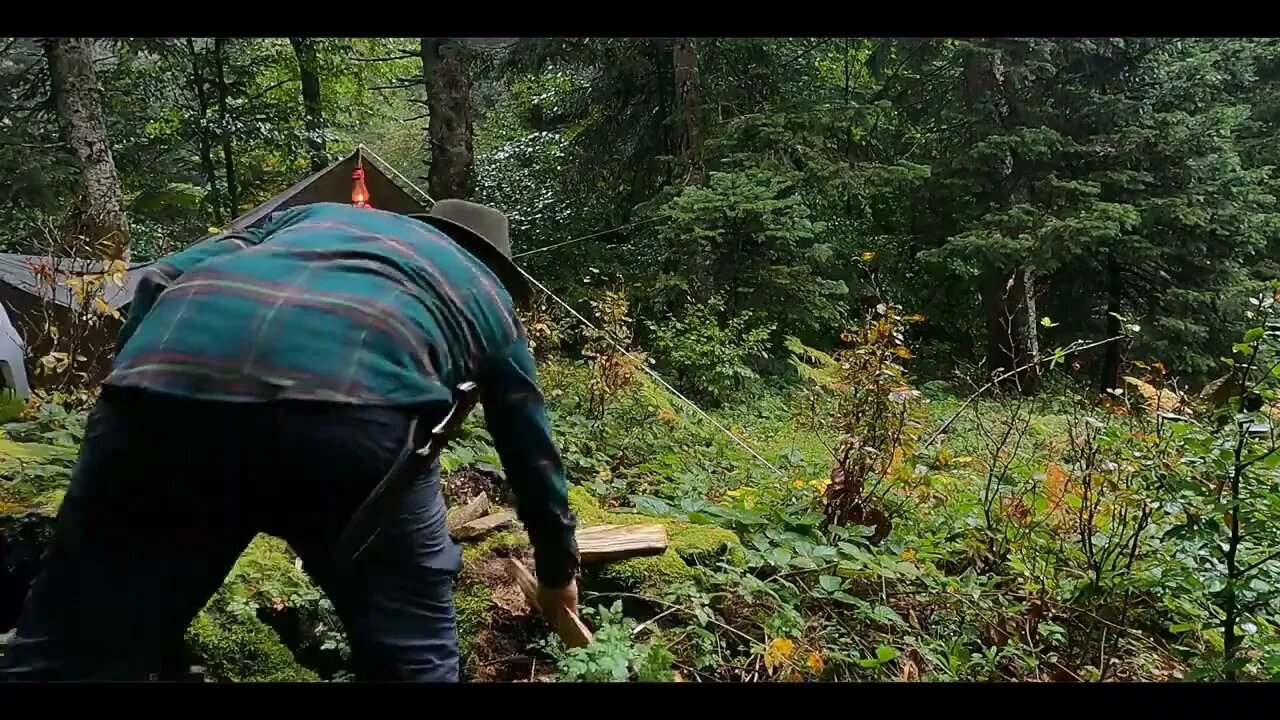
[[421, 37, 475, 200]]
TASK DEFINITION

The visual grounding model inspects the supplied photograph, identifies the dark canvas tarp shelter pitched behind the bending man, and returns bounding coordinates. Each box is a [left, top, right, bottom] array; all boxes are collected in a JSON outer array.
[[0, 145, 431, 310]]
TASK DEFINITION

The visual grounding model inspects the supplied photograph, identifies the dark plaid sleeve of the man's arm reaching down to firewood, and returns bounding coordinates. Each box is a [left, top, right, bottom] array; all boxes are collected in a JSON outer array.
[[480, 340, 579, 588]]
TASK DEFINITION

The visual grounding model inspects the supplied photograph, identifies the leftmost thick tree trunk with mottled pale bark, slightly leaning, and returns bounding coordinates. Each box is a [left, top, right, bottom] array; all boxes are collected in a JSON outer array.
[[44, 37, 129, 261]]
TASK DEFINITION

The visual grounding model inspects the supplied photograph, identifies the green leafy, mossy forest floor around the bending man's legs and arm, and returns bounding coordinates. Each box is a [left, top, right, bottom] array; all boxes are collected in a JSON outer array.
[[0, 351, 1280, 682]]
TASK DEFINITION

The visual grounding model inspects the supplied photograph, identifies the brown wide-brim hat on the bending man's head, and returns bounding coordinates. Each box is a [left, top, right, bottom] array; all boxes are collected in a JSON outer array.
[[410, 199, 532, 305]]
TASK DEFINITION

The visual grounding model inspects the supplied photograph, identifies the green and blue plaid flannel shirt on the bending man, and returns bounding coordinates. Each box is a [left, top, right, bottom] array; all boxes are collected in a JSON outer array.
[[105, 204, 576, 584]]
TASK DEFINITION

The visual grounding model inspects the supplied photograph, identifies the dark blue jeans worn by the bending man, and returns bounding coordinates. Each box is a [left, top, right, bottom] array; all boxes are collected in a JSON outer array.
[[0, 389, 461, 682]]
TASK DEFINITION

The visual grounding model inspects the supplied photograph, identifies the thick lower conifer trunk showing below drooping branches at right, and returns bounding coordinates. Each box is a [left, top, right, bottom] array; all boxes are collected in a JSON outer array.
[[983, 268, 1039, 393]]
